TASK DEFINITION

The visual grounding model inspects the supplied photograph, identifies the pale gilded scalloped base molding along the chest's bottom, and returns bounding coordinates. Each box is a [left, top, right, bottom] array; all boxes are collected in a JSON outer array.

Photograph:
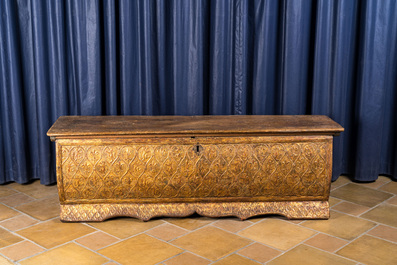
[[60, 201, 329, 222]]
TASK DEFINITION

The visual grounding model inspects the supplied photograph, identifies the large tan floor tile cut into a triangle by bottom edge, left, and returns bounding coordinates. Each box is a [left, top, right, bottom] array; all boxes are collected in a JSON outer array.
[[20, 243, 108, 265]]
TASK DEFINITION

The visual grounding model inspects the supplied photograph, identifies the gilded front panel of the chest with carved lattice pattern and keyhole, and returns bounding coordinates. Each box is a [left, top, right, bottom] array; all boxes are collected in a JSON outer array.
[[58, 138, 331, 202]]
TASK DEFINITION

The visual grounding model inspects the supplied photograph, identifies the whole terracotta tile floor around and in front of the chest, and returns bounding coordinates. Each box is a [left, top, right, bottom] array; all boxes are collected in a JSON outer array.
[[0, 176, 397, 265]]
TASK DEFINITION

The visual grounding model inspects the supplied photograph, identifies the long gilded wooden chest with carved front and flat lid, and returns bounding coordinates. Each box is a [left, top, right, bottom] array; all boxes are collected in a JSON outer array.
[[47, 116, 343, 221]]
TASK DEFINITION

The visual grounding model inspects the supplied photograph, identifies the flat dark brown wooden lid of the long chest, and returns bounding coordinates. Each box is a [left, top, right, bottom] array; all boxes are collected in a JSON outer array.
[[47, 115, 343, 139]]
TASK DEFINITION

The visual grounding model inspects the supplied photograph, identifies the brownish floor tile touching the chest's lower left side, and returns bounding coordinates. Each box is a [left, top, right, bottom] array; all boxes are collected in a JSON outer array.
[[15, 195, 60, 221]]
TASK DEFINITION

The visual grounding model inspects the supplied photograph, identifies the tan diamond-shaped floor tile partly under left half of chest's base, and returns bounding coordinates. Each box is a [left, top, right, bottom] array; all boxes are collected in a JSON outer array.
[[87, 218, 164, 239]]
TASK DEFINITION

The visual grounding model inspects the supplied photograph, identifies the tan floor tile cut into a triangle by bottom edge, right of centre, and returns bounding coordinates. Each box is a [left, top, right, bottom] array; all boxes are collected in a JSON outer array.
[[267, 245, 356, 265]]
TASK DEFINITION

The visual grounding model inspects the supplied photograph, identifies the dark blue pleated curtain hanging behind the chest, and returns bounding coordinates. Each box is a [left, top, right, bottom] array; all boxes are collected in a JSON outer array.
[[0, 0, 397, 184]]
